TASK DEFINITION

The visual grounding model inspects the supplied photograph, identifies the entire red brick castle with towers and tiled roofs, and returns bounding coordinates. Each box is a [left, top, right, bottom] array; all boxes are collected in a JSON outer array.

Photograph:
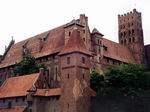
[[0, 9, 150, 112]]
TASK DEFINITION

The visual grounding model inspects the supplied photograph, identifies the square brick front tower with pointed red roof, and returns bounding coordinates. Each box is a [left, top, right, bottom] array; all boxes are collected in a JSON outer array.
[[59, 27, 91, 112]]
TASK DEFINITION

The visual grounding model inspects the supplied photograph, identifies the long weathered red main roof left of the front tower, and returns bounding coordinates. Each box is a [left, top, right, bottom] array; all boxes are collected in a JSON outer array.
[[0, 25, 65, 68]]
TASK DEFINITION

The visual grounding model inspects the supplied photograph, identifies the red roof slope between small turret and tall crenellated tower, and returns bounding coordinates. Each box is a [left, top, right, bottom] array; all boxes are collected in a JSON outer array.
[[102, 38, 135, 63]]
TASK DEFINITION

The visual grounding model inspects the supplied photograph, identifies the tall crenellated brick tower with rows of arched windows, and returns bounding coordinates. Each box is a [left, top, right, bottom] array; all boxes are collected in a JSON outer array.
[[118, 9, 144, 64]]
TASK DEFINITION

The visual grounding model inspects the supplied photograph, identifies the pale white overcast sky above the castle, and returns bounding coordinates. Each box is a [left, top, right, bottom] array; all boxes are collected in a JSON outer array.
[[0, 0, 150, 54]]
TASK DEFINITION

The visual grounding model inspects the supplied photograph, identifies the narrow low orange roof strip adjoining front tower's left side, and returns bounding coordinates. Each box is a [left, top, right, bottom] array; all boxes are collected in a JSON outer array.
[[34, 88, 61, 96]]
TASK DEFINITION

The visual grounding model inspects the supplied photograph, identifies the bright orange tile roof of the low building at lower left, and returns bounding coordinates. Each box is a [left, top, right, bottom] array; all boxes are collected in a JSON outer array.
[[0, 73, 39, 98]]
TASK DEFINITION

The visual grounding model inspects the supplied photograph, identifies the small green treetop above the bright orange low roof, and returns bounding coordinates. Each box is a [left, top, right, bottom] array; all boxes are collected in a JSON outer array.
[[13, 56, 45, 76]]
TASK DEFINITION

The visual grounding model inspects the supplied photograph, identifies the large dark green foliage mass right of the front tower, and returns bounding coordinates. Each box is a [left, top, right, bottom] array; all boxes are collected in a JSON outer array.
[[91, 64, 150, 96]]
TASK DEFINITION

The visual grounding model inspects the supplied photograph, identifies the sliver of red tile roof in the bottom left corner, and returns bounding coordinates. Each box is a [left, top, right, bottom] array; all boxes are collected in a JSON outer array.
[[0, 106, 26, 112]]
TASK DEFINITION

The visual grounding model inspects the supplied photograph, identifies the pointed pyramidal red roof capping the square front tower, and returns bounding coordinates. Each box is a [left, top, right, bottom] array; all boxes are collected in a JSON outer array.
[[59, 27, 91, 55]]
